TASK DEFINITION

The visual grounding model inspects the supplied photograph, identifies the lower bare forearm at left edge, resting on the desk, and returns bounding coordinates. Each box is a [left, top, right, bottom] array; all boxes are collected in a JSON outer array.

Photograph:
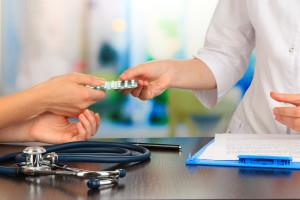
[[0, 118, 33, 142]]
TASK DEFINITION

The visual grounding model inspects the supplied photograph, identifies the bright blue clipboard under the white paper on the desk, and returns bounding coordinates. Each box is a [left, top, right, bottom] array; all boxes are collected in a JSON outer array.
[[186, 139, 300, 169]]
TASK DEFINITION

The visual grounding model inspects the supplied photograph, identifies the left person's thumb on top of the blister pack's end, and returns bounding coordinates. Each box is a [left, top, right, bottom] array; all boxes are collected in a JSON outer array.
[[71, 72, 105, 86]]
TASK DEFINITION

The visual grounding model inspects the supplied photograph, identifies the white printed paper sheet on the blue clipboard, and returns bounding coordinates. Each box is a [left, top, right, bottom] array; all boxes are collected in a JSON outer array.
[[199, 133, 300, 162]]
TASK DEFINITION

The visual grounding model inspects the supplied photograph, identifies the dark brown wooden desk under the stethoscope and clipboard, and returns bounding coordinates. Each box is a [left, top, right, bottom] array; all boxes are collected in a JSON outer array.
[[0, 138, 300, 200]]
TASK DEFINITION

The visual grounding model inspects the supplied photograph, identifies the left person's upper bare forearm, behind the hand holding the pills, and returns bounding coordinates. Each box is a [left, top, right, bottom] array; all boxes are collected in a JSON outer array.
[[0, 89, 44, 130]]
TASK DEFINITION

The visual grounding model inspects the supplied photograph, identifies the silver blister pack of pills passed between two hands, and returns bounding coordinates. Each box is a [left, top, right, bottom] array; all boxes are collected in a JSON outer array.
[[86, 80, 138, 90]]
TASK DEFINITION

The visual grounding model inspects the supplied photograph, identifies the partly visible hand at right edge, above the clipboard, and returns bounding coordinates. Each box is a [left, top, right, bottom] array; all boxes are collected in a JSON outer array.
[[271, 92, 300, 131]]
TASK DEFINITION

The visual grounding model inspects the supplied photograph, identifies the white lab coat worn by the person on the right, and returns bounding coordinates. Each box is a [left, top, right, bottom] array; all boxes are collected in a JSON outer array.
[[194, 0, 300, 134]]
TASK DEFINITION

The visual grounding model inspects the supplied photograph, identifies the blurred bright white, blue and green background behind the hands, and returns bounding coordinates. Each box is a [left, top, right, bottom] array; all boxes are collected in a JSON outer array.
[[0, 0, 255, 137]]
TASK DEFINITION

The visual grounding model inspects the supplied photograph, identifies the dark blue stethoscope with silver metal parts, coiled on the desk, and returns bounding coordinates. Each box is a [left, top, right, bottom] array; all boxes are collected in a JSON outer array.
[[0, 141, 151, 189]]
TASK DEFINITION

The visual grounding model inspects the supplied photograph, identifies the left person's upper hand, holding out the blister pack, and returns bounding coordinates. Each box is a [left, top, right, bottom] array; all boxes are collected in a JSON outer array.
[[29, 73, 106, 118]]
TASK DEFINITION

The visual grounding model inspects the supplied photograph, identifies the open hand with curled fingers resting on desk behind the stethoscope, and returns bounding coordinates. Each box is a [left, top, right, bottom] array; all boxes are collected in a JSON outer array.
[[28, 110, 100, 144]]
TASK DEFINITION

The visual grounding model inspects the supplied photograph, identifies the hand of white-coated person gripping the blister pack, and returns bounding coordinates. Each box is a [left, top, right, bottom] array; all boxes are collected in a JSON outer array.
[[116, 60, 171, 100]]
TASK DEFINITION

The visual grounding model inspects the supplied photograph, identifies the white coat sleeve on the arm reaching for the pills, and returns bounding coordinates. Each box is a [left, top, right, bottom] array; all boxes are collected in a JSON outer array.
[[194, 0, 255, 108]]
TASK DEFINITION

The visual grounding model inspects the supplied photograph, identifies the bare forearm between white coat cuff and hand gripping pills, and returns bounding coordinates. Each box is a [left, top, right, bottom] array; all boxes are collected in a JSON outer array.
[[165, 58, 217, 90]]
